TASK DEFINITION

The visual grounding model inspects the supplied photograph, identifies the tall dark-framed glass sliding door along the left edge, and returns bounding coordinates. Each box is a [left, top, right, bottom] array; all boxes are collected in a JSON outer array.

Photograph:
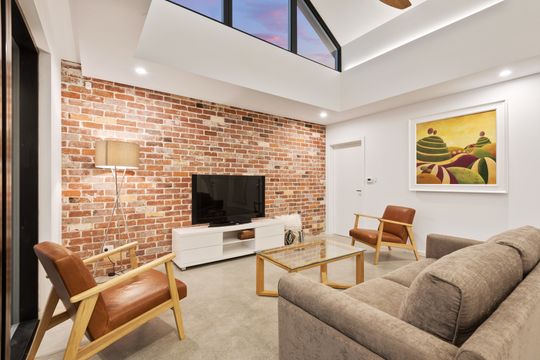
[[8, 1, 39, 360]]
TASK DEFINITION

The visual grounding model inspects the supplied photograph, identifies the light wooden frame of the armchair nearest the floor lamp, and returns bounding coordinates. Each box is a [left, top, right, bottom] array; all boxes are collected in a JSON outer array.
[[26, 242, 185, 360]]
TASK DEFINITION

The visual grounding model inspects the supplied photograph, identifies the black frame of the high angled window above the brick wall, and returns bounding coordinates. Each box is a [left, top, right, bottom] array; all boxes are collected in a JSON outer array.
[[166, 0, 341, 72]]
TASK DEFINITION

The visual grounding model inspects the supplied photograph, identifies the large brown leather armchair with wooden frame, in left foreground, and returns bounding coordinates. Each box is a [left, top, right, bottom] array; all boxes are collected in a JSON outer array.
[[26, 242, 187, 360]]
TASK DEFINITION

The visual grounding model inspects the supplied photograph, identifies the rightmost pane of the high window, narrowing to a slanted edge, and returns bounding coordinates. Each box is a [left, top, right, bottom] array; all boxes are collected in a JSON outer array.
[[297, 0, 337, 69]]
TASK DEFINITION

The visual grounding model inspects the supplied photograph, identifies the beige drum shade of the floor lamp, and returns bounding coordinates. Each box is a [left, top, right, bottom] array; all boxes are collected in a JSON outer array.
[[96, 140, 139, 169]]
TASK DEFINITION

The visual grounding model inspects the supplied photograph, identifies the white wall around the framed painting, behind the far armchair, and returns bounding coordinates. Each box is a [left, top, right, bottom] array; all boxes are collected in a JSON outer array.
[[327, 75, 540, 250]]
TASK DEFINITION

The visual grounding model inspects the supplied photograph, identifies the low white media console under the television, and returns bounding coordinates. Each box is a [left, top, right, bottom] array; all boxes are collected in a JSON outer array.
[[172, 219, 284, 269]]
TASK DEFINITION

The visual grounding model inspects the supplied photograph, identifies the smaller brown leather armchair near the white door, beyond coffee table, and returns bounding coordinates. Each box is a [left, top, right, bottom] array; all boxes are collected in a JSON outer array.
[[349, 205, 418, 265]]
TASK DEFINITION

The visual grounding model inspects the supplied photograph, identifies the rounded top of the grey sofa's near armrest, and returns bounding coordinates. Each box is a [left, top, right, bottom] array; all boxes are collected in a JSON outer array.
[[278, 274, 458, 360]]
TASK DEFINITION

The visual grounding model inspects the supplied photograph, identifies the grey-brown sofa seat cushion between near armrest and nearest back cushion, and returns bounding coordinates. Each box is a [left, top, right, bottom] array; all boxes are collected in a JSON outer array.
[[344, 278, 407, 317]]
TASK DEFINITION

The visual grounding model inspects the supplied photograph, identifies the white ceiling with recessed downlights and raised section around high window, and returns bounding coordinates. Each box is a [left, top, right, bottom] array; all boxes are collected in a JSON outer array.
[[18, 0, 540, 124]]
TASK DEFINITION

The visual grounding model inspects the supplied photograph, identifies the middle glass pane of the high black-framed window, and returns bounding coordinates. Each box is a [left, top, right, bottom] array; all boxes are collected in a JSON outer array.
[[232, 0, 289, 49]]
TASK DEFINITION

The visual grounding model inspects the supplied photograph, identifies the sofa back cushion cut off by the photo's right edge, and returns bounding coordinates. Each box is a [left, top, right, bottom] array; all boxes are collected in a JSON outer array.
[[488, 226, 540, 275]]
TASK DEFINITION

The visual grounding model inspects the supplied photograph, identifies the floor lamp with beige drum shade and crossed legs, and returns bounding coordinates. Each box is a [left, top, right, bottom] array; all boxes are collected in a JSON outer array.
[[95, 140, 139, 255]]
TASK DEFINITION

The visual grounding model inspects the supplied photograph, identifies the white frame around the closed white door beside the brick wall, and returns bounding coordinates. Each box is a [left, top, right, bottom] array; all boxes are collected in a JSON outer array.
[[326, 136, 366, 234]]
